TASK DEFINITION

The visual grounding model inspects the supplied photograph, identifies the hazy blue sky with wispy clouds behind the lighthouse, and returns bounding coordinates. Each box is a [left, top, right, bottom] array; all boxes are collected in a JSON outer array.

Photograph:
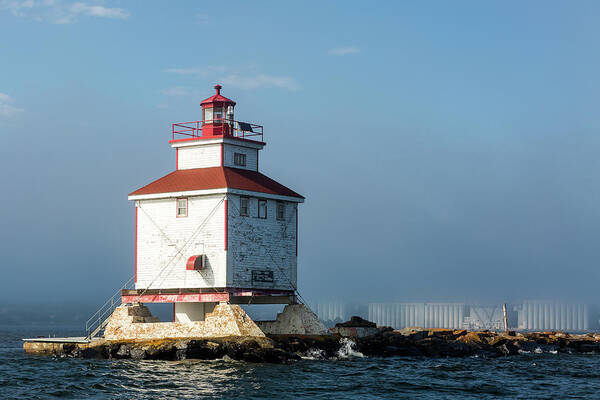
[[0, 0, 600, 303]]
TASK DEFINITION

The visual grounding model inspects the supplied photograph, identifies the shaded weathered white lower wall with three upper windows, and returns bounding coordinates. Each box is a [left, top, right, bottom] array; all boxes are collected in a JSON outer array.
[[227, 195, 297, 289]]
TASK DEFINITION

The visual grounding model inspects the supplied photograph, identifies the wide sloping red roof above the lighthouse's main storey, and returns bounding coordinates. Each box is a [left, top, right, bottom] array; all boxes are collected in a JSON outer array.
[[129, 167, 304, 199]]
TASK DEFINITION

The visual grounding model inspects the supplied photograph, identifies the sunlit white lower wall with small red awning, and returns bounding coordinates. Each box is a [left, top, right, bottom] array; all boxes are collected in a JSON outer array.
[[136, 195, 226, 289]]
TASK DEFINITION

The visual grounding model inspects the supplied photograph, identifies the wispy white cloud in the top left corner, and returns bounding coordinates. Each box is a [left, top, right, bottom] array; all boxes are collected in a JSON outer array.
[[0, 0, 129, 24]]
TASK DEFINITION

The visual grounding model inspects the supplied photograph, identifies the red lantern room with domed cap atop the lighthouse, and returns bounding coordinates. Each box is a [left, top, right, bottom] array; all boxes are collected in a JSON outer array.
[[200, 85, 235, 137]]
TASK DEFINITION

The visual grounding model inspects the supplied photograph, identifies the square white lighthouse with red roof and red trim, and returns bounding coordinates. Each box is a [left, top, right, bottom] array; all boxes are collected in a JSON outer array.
[[122, 85, 304, 322]]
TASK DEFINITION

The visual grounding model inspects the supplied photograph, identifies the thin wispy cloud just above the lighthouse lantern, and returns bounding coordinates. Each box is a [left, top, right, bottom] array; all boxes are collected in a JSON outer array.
[[163, 65, 300, 94]]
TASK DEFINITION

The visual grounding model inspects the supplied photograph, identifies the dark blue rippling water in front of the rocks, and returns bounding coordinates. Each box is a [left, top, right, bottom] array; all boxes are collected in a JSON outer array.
[[0, 326, 600, 400]]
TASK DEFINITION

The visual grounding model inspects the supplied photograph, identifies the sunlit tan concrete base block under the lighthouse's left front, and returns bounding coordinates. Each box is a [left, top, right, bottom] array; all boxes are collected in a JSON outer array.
[[104, 304, 265, 340]]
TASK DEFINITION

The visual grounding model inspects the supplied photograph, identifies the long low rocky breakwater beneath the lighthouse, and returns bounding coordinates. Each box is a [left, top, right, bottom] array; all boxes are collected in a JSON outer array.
[[23, 317, 600, 363]]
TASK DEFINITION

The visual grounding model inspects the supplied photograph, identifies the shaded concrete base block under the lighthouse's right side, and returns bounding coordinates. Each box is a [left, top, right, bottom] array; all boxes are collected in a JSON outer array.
[[256, 304, 331, 335]]
